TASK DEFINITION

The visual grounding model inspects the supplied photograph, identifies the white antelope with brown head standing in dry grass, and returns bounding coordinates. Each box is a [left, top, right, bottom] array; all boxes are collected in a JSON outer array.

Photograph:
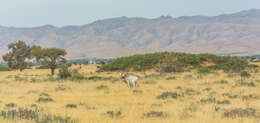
[[121, 74, 138, 88]]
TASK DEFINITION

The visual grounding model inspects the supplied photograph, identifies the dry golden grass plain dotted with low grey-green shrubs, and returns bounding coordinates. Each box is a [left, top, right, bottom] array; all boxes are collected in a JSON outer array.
[[0, 65, 260, 123]]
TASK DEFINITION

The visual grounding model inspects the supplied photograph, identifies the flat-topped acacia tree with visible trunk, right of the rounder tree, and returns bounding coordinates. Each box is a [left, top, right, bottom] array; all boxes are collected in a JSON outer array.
[[31, 46, 67, 75]]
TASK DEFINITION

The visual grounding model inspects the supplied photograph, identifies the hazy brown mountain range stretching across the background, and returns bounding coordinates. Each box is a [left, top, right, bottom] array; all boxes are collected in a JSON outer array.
[[0, 9, 260, 58]]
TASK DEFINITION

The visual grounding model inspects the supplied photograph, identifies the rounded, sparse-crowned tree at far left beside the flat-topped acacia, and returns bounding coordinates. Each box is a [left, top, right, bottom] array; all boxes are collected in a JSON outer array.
[[2, 41, 31, 71]]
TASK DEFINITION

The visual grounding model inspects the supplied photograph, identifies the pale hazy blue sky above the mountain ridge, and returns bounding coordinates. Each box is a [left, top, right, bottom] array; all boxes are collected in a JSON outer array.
[[0, 0, 260, 27]]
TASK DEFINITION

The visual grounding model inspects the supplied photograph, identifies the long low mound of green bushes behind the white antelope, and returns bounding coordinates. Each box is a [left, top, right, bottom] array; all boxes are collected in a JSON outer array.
[[99, 52, 248, 73]]
